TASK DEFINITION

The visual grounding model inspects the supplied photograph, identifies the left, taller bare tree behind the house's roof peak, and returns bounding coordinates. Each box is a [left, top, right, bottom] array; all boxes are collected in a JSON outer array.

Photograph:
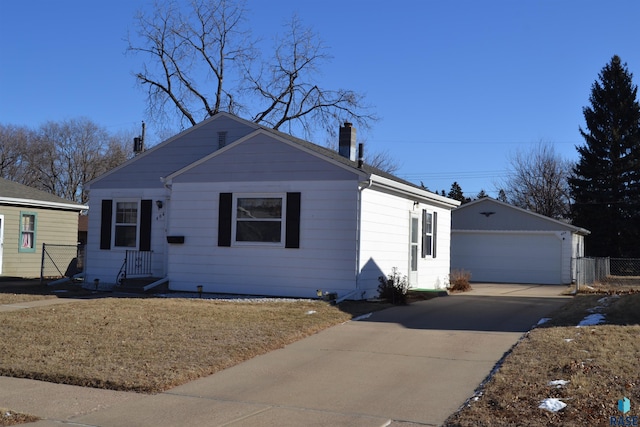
[[128, 0, 255, 130]]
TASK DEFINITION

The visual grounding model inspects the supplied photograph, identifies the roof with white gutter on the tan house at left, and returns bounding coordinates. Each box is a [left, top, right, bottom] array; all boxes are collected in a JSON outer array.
[[0, 178, 89, 211]]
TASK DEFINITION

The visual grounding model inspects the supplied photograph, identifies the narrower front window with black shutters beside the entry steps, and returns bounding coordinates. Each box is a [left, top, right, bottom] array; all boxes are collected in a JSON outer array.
[[100, 199, 153, 251]]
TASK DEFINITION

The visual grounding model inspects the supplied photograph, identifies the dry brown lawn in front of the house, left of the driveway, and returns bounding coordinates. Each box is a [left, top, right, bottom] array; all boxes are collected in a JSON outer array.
[[0, 298, 385, 393]]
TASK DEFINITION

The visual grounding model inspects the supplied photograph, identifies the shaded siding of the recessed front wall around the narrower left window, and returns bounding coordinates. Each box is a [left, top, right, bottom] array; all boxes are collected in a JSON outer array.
[[85, 189, 170, 284]]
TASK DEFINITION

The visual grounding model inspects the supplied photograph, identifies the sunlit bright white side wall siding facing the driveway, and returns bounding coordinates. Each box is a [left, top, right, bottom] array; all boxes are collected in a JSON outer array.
[[360, 189, 451, 296]]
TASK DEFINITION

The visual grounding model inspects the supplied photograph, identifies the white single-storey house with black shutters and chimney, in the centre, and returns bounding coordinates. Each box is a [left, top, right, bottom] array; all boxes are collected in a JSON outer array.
[[86, 113, 458, 299]]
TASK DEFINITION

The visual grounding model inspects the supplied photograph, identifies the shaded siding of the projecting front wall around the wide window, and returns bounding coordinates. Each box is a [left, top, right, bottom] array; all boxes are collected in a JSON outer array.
[[168, 180, 357, 297]]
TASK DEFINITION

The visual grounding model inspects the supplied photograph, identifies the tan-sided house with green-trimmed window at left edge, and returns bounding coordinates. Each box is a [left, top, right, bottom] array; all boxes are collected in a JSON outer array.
[[0, 178, 88, 278]]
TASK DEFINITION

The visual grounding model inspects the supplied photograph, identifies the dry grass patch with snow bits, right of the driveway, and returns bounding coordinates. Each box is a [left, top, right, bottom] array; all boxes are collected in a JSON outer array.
[[446, 293, 640, 426]]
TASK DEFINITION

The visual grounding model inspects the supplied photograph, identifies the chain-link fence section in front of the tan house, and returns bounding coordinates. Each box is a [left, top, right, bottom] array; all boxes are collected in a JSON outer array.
[[40, 243, 85, 282]]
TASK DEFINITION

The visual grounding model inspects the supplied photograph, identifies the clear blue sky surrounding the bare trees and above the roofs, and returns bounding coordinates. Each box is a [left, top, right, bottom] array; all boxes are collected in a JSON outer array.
[[0, 0, 640, 196]]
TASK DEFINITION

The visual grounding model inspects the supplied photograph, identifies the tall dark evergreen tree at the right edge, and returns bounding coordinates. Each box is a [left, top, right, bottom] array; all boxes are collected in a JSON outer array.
[[569, 55, 640, 257]]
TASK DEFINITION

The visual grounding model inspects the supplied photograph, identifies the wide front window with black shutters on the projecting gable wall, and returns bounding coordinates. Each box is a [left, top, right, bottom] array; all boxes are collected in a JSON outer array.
[[218, 193, 301, 248]]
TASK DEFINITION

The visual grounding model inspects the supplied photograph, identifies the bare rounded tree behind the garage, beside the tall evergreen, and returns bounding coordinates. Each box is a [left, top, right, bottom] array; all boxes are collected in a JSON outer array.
[[500, 142, 571, 219]]
